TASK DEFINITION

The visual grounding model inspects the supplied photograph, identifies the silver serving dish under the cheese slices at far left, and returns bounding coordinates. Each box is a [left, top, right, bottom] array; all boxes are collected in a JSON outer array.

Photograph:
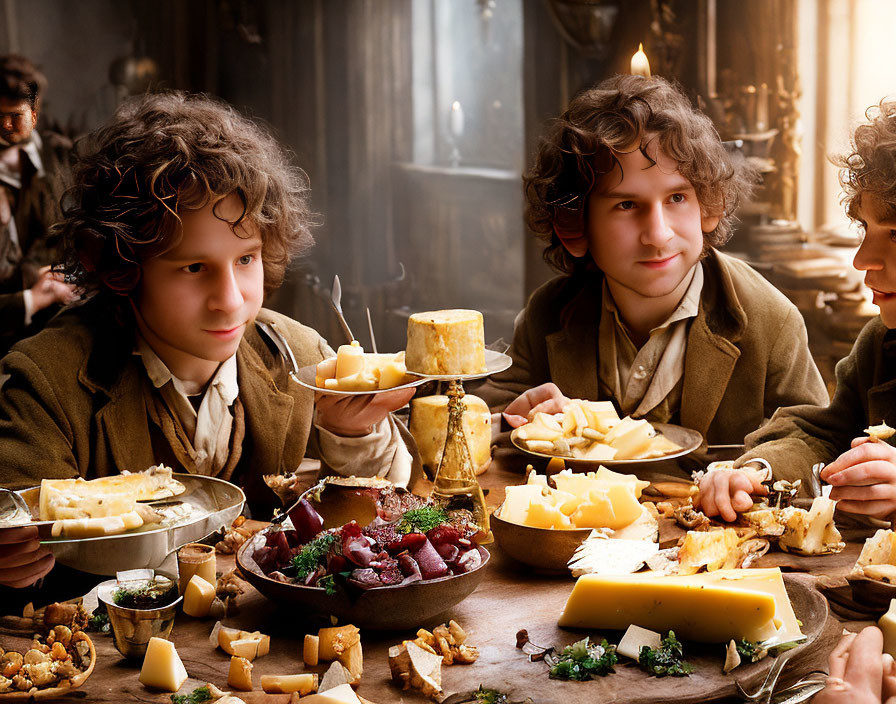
[[19, 474, 246, 575]]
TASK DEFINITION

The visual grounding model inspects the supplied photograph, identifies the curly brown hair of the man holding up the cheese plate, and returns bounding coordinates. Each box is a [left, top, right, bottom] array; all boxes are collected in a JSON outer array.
[[57, 92, 314, 295]]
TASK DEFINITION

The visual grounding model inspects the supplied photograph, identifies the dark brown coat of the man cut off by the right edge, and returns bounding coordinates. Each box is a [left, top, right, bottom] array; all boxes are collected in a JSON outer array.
[[738, 317, 896, 485]]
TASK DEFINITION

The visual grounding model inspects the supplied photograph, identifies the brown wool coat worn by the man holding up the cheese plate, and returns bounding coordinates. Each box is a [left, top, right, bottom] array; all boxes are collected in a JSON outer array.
[[0, 303, 416, 506]]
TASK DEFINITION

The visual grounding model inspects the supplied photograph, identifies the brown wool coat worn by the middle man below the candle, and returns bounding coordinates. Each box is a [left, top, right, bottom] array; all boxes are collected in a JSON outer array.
[[476, 250, 828, 454]]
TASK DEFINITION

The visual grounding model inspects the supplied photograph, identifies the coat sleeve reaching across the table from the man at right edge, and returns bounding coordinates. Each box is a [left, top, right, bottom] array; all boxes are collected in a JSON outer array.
[[736, 320, 876, 486]]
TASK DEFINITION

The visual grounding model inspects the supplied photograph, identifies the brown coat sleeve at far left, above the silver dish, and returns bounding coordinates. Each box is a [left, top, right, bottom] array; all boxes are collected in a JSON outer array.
[[0, 351, 79, 489]]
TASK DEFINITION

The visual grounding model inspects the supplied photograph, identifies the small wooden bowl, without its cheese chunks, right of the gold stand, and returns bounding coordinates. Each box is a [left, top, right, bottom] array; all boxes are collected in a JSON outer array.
[[490, 509, 591, 575]]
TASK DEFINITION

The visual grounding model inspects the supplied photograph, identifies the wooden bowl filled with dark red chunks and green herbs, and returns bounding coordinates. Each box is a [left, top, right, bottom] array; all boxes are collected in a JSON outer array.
[[236, 478, 489, 630]]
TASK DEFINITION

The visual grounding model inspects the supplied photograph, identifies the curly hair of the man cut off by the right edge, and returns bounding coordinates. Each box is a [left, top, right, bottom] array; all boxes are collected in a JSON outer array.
[[832, 98, 896, 220]]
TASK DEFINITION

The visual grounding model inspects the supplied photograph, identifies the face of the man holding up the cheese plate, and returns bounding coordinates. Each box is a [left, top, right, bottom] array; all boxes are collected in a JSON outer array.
[[132, 195, 264, 385]]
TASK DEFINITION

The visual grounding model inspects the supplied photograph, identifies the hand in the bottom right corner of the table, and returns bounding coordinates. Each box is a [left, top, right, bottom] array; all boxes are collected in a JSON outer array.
[[812, 626, 896, 704]]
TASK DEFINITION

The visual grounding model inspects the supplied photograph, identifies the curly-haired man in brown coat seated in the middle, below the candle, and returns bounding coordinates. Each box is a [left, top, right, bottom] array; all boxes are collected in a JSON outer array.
[[482, 76, 827, 478]]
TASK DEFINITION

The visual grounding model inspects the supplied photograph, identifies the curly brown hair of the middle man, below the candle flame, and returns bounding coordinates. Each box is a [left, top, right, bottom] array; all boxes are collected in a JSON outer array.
[[523, 75, 756, 273]]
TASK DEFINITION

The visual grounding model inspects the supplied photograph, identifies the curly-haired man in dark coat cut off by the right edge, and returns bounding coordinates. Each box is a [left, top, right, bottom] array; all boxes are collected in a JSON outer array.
[[700, 100, 896, 519]]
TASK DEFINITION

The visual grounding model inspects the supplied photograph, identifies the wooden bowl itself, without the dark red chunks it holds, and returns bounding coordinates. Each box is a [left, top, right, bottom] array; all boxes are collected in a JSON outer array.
[[236, 528, 489, 630]]
